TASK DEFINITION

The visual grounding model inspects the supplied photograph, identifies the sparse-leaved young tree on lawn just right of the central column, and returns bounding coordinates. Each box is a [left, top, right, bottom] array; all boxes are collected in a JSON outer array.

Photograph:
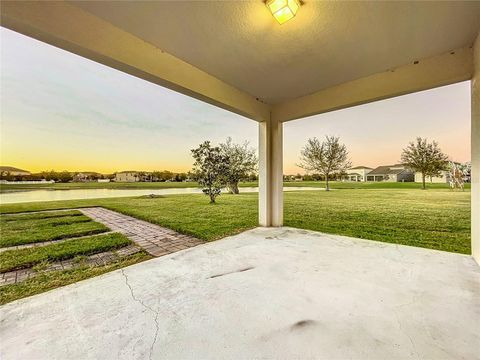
[[299, 136, 350, 191]]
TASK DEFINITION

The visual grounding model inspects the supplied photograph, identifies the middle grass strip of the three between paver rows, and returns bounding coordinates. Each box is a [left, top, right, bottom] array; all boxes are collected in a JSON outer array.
[[0, 233, 131, 272]]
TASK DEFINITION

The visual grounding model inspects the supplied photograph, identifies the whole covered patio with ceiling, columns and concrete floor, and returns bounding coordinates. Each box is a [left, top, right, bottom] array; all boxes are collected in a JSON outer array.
[[1, 0, 480, 359]]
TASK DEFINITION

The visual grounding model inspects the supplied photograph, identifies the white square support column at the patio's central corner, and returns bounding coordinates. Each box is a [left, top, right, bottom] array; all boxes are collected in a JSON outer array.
[[258, 120, 283, 226]]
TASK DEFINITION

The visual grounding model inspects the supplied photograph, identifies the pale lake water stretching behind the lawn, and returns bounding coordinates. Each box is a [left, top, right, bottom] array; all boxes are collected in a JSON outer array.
[[0, 186, 322, 204]]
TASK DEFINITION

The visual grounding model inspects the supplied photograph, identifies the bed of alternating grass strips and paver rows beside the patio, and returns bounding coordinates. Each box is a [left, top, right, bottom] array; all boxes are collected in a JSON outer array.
[[0, 210, 151, 304]]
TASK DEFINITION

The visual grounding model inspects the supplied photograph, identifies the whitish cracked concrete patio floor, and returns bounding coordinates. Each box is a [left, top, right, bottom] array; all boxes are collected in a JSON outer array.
[[0, 228, 480, 360]]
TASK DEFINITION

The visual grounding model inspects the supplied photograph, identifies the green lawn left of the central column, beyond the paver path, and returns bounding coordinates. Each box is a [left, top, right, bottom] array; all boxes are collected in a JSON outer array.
[[0, 194, 258, 240]]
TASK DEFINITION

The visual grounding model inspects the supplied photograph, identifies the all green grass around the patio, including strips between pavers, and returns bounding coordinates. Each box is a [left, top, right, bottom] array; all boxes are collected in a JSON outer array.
[[0, 188, 470, 304]]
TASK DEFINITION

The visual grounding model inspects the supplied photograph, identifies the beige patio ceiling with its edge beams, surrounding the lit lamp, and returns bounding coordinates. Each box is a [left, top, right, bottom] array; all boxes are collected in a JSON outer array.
[[2, 0, 480, 121]]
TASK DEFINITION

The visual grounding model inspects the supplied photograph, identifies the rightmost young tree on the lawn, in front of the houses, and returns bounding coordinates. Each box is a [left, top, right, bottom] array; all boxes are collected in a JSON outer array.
[[401, 137, 448, 190]]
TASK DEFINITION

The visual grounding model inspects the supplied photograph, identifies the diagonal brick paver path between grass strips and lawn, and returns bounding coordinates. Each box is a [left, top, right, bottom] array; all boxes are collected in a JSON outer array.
[[78, 207, 204, 256]]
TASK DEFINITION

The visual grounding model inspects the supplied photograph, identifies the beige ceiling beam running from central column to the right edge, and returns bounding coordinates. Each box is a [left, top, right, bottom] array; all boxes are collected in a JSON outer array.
[[272, 47, 473, 122]]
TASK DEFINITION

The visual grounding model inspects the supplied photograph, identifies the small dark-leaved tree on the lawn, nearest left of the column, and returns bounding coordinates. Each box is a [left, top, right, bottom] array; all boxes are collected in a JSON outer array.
[[191, 141, 229, 203]]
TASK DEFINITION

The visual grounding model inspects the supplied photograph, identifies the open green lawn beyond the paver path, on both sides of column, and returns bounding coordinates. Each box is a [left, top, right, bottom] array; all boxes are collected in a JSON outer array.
[[0, 189, 470, 254]]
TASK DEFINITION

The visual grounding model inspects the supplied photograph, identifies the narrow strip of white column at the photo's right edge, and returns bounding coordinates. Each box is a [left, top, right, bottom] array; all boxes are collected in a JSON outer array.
[[471, 34, 480, 265]]
